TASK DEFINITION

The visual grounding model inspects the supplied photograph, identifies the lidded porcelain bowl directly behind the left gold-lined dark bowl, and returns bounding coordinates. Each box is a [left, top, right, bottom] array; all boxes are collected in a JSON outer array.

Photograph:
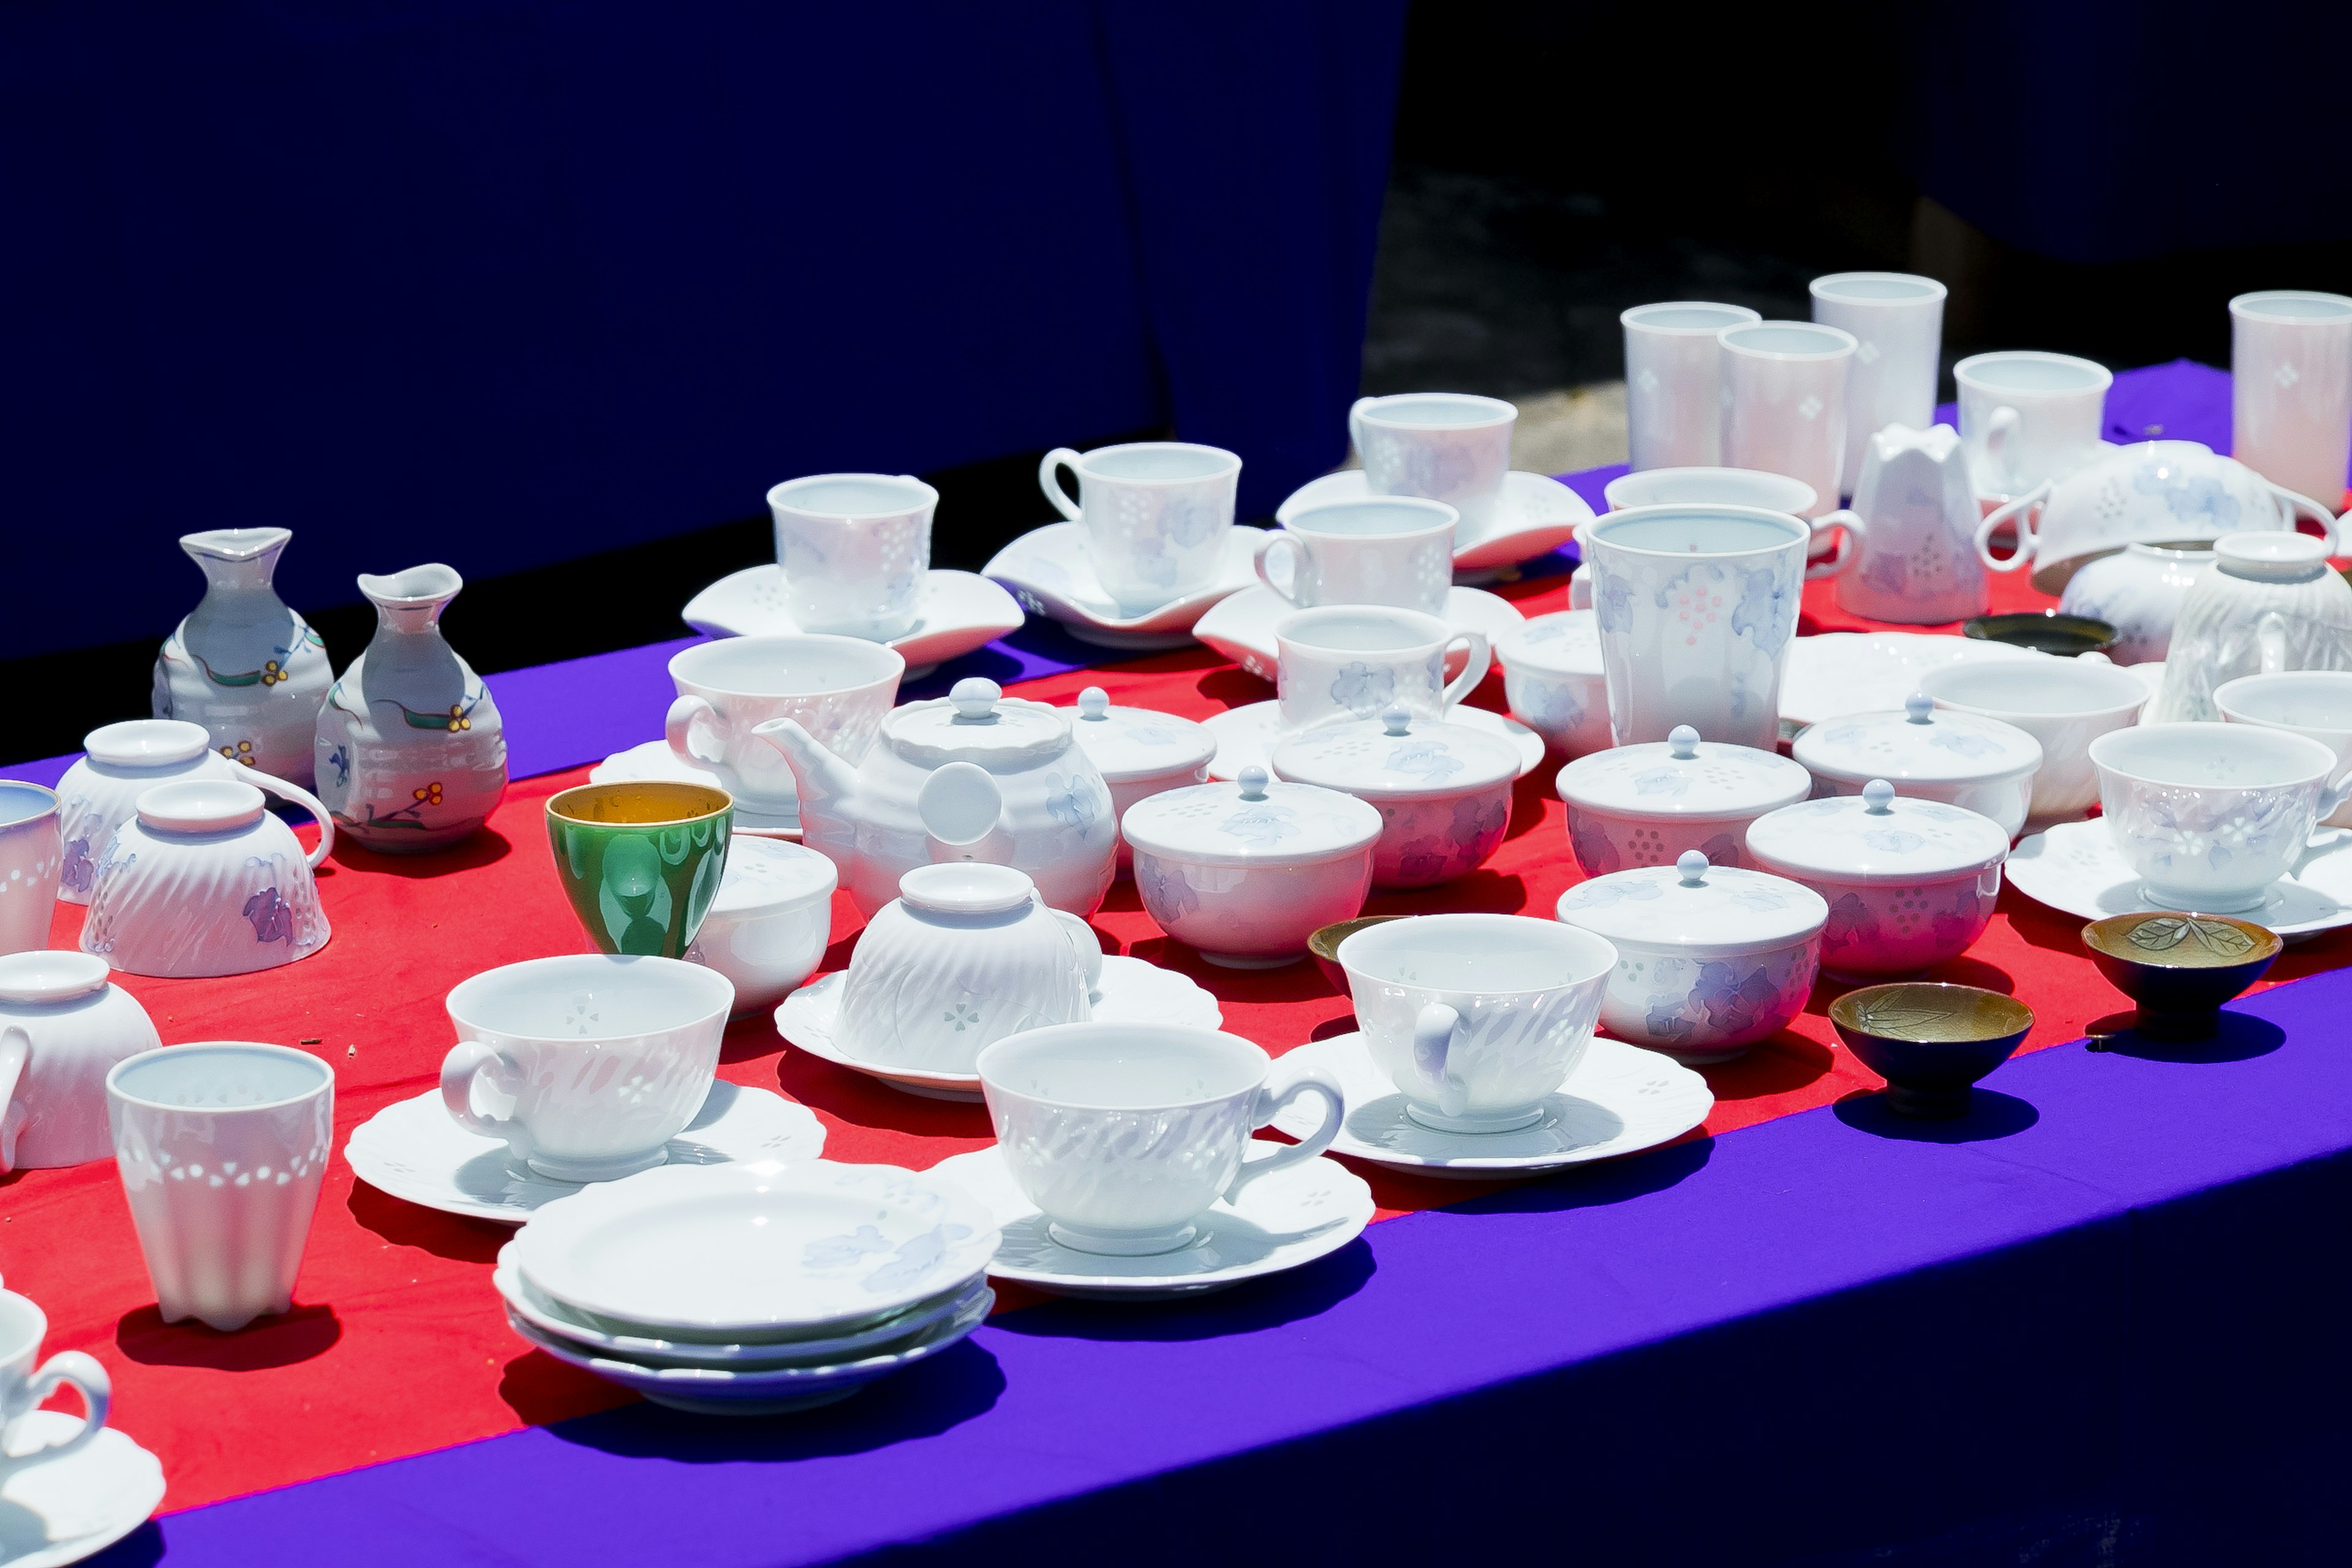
[[1747, 778, 2008, 980]]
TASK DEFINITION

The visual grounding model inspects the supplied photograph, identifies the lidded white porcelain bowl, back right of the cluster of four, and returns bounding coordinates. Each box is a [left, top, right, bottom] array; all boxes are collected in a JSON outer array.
[[1790, 691, 2041, 837]]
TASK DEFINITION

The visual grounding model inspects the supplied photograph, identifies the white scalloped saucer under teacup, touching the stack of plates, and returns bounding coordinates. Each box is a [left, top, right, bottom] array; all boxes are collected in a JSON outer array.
[[932, 1142, 1374, 1300]]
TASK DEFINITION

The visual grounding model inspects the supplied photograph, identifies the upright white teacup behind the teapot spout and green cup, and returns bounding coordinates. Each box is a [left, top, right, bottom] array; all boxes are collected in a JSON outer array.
[[666, 635, 905, 816]]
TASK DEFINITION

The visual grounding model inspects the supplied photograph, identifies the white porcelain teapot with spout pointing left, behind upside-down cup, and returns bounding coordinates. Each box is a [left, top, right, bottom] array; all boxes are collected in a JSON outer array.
[[753, 677, 1120, 917]]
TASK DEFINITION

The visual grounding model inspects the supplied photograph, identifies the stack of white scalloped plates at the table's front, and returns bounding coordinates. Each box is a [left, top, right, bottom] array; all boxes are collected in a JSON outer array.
[[494, 1159, 997, 1415]]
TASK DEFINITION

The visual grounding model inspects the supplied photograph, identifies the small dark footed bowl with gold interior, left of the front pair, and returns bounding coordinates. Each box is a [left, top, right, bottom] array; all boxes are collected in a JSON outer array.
[[1830, 980, 2035, 1119]]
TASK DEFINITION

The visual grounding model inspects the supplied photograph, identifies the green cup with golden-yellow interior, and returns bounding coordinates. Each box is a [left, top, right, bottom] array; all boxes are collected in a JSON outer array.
[[548, 780, 734, 959]]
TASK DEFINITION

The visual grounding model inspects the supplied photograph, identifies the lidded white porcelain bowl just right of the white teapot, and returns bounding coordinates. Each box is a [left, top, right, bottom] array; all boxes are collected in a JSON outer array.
[[1120, 766, 1381, 968]]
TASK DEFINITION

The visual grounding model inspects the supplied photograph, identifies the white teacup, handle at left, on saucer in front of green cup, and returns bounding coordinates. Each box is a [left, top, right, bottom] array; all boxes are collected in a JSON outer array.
[[442, 952, 734, 1183]]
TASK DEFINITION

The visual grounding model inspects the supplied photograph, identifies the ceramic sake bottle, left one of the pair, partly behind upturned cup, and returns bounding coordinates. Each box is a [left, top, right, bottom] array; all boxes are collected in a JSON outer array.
[[155, 529, 334, 785]]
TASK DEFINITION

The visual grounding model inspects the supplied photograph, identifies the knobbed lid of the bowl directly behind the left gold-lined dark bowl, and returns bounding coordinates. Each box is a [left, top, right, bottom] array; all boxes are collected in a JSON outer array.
[[1747, 778, 2008, 881]]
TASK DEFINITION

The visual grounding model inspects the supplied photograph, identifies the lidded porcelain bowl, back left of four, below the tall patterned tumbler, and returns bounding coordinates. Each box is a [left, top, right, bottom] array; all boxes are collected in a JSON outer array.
[[1559, 724, 1814, 877]]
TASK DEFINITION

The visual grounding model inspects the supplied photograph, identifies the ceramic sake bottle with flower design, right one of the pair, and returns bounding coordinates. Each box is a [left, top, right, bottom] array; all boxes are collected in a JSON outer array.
[[315, 564, 506, 853]]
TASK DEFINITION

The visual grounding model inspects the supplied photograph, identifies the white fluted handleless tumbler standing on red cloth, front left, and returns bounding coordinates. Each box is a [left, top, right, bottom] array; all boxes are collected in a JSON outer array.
[[106, 1039, 334, 1333]]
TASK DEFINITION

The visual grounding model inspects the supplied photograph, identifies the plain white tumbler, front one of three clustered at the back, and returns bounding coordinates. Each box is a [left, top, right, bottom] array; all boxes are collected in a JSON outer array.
[[1717, 322, 1856, 510]]
